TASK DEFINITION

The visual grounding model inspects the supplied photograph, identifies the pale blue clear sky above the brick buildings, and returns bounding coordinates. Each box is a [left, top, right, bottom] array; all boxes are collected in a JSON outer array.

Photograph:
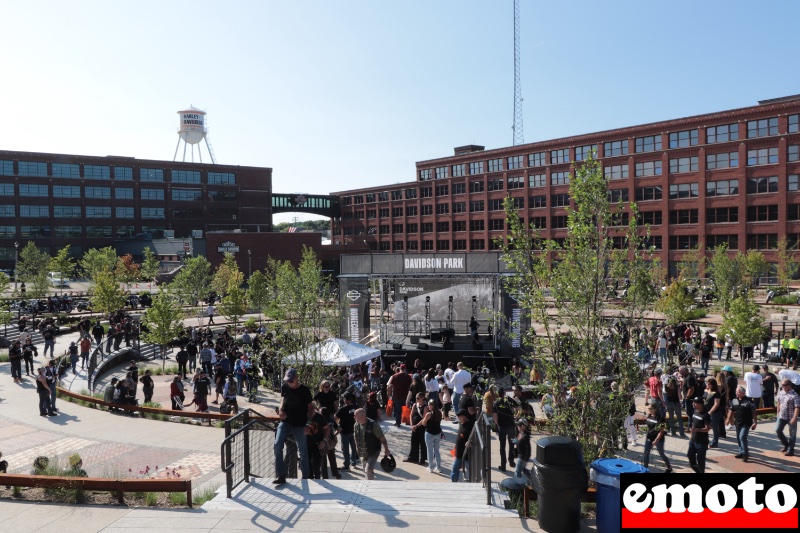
[[0, 0, 800, 222]]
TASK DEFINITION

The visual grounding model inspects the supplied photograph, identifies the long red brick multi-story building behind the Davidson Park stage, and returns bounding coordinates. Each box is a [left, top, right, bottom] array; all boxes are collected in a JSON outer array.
[[333, 96, 800, 272]]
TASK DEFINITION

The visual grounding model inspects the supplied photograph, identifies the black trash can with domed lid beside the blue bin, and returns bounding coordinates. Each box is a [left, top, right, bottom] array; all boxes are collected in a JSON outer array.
[[531, 437, 589, 533]]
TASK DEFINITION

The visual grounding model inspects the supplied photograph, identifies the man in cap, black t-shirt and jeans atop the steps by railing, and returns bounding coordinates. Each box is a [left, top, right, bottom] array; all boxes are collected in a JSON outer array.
[[272, 368, 316, 485]]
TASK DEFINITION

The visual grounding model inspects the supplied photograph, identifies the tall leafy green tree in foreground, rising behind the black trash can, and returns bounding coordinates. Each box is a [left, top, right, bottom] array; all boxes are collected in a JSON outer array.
[[503, 157, 658, 462]]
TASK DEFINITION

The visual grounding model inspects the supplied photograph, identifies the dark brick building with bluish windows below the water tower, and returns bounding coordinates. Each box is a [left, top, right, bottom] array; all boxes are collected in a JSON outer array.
[[0, 151, 272, 267]]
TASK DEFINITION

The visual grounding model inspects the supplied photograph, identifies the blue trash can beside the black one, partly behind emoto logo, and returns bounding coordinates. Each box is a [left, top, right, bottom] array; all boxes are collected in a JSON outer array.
[[590, 459, 649, 533]]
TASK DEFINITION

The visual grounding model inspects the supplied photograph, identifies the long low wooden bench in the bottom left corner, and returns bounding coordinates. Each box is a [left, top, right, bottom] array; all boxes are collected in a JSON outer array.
[[0, 474, 192, 507]]
